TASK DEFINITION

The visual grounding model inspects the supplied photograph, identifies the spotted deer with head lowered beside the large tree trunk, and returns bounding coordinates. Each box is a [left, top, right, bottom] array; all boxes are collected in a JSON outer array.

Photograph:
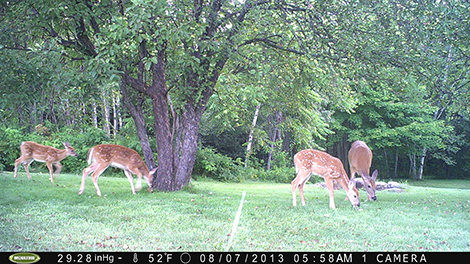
[[78, 144, 157, 196]]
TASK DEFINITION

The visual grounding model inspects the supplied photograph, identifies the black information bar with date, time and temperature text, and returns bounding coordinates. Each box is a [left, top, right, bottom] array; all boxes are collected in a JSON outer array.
[[0, 251, 470, 264]]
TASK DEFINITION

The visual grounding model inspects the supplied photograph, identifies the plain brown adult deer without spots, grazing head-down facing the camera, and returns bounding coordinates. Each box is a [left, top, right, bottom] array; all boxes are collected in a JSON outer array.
[[348, 140, 377, 201]]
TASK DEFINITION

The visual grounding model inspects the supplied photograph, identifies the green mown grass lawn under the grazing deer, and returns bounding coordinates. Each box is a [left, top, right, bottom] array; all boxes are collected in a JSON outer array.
[[0, 171, 470, 251]]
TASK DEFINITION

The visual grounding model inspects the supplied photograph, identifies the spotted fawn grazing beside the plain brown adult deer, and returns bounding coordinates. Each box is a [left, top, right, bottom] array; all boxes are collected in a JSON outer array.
[[292, 149, 360, 209]]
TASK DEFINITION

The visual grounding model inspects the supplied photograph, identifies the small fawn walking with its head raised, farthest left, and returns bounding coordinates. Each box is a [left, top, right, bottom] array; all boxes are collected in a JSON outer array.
[[14, 141, 77, 183]]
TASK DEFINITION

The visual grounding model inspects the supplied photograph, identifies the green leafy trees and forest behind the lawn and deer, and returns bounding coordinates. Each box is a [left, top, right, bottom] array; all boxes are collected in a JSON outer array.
[[0, 0, 470, 186]]
